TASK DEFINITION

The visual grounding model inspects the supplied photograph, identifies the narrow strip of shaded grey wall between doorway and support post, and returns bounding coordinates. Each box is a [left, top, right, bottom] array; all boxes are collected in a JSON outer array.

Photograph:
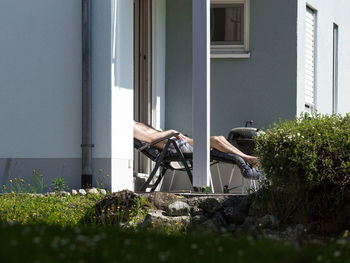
[[165, 0, 192, 134]]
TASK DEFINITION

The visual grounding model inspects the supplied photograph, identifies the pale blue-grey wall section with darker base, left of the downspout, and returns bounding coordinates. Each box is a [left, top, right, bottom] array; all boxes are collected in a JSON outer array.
[[0, 0, 81, 190]]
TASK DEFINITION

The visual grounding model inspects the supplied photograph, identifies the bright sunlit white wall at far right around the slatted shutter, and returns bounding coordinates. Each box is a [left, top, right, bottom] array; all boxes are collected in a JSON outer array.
[[297, 0, 350, 114]]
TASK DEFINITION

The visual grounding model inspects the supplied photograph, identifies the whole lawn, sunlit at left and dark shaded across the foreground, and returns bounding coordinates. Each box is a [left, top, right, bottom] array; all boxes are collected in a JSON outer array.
[[0, 194, 350, 263]]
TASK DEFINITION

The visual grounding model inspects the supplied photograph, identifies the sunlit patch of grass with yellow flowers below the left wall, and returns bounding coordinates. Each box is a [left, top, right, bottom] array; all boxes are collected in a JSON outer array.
[[0, 194, 101, 226]]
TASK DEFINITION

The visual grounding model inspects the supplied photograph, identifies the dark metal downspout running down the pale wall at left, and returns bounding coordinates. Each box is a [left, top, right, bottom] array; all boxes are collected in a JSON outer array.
[[81, 0, 94, 188]]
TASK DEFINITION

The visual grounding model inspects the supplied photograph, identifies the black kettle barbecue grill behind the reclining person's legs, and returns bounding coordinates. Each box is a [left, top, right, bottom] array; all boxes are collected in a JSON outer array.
[[228, 120, 259, 155]]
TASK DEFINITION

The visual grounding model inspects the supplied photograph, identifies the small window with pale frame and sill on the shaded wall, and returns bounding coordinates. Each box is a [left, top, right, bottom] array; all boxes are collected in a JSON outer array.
[[210, 0, 249, 58]]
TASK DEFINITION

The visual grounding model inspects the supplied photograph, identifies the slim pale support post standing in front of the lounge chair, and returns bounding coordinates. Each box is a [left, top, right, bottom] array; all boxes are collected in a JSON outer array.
[[192, 0, 210, 186]]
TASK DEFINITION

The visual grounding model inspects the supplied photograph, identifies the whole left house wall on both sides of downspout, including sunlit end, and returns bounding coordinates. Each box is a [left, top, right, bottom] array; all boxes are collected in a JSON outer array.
[[0, 0, 133, 191]]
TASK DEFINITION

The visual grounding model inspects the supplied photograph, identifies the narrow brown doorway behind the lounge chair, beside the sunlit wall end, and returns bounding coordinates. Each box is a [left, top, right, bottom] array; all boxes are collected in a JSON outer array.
[[134, 0, 152, 177]]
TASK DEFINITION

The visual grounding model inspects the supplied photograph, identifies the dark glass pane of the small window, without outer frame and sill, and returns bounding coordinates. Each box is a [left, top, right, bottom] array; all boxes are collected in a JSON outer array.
[[210, 4, 244, 45]]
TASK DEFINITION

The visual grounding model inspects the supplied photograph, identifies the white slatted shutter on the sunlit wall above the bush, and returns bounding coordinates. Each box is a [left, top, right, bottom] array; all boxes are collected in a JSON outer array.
[[305, 7, 316, 112]]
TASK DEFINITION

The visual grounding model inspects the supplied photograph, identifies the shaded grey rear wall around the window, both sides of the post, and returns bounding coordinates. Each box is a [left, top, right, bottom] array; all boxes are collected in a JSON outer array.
[[166, 0, 297, 135]]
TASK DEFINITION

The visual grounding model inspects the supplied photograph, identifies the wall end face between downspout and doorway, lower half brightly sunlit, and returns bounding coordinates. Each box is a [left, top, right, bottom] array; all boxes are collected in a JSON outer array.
[[111, 0, 134, 192]]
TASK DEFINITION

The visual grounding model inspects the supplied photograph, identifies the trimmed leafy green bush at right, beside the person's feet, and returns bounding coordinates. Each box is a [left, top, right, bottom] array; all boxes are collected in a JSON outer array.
[[256, 114, 350, 234]]
